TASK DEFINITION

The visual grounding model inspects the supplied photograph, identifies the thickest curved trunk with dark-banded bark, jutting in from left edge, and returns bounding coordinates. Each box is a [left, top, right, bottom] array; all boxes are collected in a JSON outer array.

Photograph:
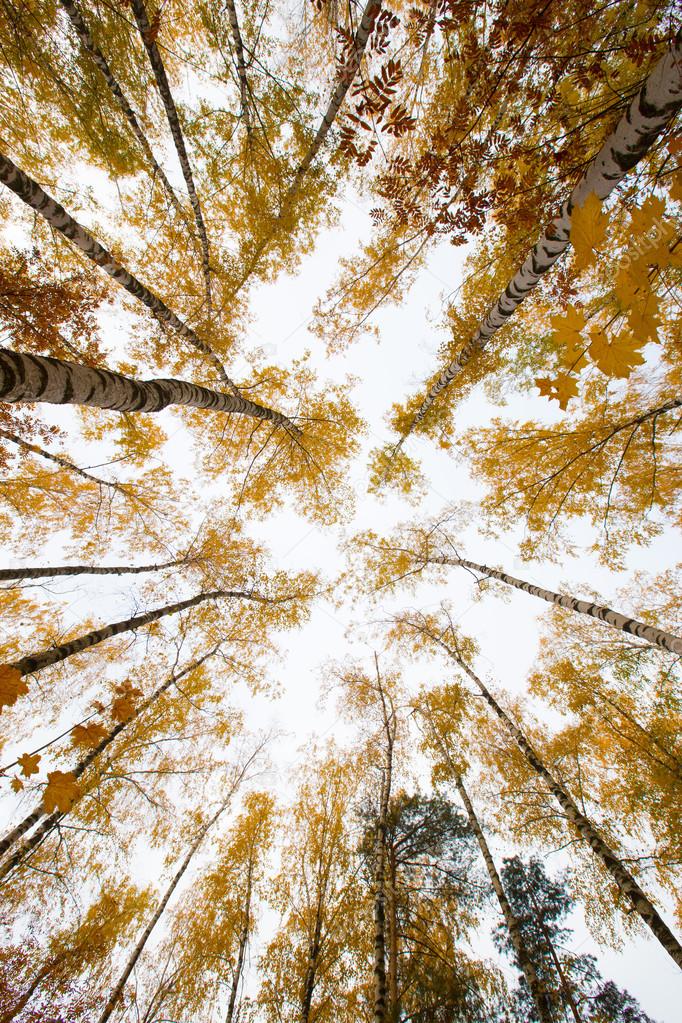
[[0, 348, 301, 433]]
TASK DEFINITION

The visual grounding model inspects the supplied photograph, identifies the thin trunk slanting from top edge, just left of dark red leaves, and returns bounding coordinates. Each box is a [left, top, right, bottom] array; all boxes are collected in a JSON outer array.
[[226, 0, 382, 298]]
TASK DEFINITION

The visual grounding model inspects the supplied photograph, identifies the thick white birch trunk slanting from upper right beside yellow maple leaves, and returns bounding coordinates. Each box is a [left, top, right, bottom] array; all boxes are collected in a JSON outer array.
[[394, 32, 682, 441]]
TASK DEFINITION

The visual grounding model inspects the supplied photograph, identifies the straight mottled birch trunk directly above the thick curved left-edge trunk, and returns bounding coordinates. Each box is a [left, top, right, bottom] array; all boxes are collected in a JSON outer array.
[[0, 152, 239, 396]]
